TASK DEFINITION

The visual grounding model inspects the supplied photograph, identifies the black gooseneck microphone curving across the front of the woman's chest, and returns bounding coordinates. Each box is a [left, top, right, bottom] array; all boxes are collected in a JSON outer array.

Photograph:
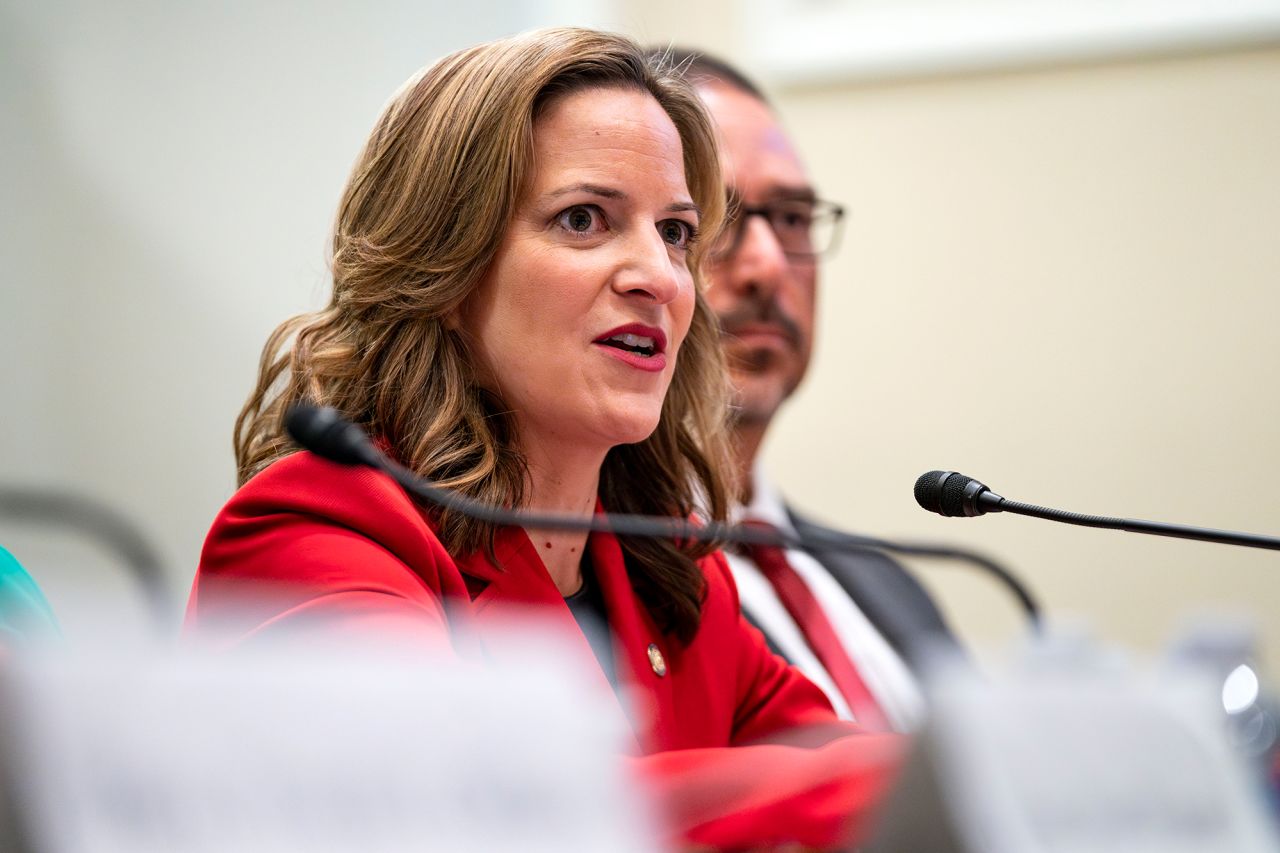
[[284, 402, 1041, 625]]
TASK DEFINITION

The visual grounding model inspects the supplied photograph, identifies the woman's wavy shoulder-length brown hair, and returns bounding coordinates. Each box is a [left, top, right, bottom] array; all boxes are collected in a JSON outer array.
[[234, 28, 730, 642]]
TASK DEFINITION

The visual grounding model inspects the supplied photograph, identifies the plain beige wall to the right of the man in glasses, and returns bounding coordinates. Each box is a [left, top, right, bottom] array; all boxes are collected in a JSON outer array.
[[631, 4, 1280, 670]]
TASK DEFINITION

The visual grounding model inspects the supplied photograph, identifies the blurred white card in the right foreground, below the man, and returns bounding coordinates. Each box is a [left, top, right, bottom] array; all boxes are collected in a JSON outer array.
[[865, 630, 1280, 853]]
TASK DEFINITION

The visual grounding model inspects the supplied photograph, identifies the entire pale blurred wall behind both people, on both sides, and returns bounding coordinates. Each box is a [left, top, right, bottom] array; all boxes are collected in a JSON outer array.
[[0, 0, 1280, 655]]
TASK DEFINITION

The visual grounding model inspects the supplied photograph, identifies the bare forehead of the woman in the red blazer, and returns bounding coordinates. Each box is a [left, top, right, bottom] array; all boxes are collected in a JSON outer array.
[[534, 87, 689, 196]]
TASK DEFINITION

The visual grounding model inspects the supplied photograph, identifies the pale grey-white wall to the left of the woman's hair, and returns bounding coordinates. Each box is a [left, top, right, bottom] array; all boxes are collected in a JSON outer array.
[[0, 0, 614, 639]]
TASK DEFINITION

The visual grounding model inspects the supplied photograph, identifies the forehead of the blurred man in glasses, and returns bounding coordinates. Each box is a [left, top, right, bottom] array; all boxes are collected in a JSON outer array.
[[698, 82, 809, 200]]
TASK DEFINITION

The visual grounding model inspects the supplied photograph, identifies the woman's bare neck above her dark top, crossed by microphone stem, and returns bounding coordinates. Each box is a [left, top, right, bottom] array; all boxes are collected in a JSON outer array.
[[525, 435, 604, 596]]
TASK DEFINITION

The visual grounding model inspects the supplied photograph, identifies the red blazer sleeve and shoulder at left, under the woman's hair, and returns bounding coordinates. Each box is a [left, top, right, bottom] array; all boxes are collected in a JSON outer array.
[[186, 453, 465, 647]]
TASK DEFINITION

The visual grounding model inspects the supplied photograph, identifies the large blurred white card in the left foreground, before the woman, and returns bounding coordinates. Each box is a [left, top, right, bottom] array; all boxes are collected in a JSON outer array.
[[0, 627, 654, 853]]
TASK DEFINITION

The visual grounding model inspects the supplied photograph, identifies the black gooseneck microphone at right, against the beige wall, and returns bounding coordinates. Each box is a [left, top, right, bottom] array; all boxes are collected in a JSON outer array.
[[915, 471, 1280, 551]]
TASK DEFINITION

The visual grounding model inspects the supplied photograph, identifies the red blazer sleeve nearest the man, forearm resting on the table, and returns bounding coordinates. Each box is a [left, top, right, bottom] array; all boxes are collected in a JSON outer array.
[[632, 553, 905, 849]]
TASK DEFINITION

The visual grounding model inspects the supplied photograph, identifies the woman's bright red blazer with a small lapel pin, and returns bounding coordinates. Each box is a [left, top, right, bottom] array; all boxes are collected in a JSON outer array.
[[187, 452, 899, 847]]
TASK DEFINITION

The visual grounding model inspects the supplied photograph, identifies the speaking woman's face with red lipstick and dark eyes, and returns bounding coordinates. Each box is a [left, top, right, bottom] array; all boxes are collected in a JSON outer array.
[[460, 88, 698, 460]]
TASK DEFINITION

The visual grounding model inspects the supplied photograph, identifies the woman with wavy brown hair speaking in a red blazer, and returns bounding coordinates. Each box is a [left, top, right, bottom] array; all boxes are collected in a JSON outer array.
[[188, 29, 896, 845]]
